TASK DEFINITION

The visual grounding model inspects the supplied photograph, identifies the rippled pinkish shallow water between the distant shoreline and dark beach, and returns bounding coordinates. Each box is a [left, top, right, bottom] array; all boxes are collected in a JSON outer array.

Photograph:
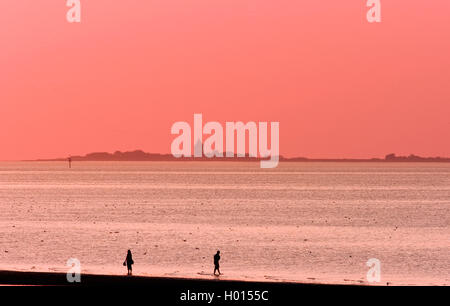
[[0, 162, 450, 285]]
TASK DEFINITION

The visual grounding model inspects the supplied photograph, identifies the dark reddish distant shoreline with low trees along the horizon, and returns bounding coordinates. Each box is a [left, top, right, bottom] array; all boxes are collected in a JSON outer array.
[[23, 150, 450, 163]]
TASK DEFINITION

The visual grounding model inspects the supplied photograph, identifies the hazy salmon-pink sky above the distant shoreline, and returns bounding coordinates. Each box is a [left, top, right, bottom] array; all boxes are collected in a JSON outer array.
[[0, 0, 450, 160]]
